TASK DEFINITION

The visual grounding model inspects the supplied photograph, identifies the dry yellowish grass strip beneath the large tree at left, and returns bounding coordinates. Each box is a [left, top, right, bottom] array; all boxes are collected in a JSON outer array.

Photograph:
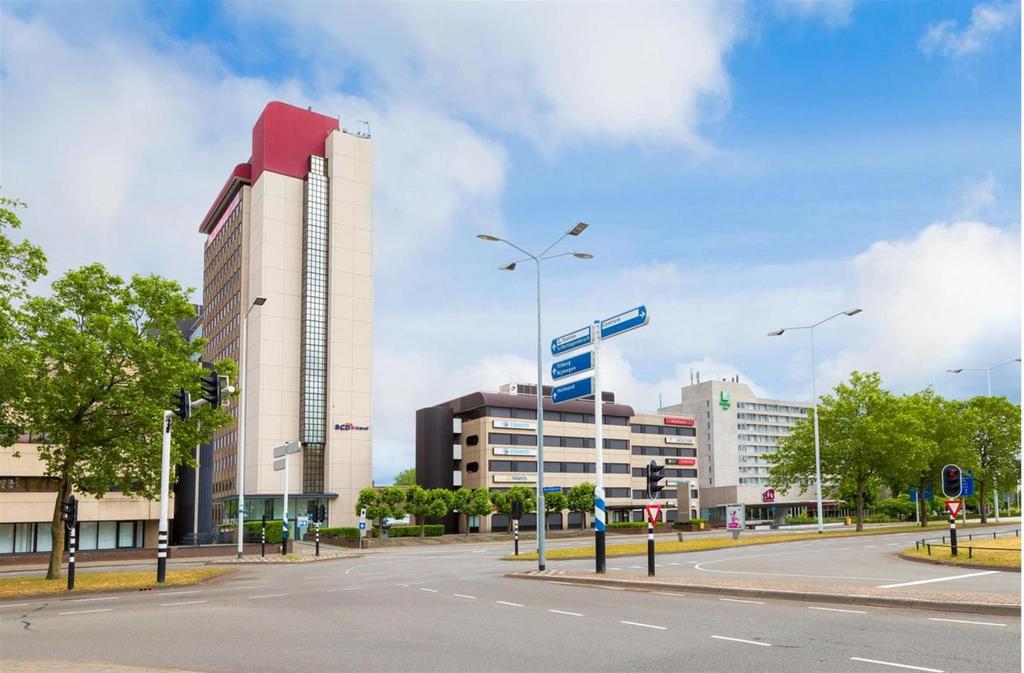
[[0, 567, 234, 598]]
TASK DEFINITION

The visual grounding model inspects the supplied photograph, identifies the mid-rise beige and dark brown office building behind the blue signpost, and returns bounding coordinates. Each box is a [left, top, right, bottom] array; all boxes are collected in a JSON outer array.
[[416, 383, 700, 532]]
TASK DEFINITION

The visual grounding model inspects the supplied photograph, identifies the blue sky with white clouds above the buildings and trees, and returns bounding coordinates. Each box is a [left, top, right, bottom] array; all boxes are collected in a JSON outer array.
[[0, 0, 1021, 481]]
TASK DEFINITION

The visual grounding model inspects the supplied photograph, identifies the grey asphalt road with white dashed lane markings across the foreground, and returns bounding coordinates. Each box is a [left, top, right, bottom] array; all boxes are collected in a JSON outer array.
[[0, 536, 1021, 673]]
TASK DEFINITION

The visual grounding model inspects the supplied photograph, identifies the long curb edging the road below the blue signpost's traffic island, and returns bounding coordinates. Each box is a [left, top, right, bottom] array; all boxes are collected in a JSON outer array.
[[505, 571, 1021, 617]]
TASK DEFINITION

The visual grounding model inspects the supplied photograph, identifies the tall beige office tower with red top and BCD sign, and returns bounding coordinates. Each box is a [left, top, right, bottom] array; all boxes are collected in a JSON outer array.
[[200, 102, 374, 531]]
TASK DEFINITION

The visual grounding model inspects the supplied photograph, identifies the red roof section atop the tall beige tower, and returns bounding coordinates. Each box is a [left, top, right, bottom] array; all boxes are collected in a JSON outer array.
[[199, 100, 339, 234]]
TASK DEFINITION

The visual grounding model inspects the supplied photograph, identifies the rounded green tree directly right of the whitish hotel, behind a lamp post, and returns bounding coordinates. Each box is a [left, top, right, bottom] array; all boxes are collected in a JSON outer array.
[[768, 372, 907, 531]]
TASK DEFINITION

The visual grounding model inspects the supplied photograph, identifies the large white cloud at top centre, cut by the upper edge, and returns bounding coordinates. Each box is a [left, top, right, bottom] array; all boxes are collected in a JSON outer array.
[[238, 3, 740, 148]]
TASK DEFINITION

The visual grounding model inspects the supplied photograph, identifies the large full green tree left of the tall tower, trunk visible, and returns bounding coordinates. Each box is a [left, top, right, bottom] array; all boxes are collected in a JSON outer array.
[[14, 264, 231, 578]]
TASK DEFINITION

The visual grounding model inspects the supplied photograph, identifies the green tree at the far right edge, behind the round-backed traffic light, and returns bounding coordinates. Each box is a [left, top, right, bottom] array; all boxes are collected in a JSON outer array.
[[962, 396, 1021, 523]]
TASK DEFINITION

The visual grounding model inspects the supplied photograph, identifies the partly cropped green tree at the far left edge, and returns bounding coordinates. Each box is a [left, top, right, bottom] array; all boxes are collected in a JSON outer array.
[[0, 197, 46, 447]]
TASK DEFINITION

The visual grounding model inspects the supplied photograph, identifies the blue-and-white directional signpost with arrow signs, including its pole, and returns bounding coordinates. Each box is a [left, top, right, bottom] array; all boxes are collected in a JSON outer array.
[[551, 305, 653, 573]]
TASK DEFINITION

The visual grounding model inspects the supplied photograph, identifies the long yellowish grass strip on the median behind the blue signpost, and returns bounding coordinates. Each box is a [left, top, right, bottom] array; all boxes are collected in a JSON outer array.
[[502, 523, 1007, 560]]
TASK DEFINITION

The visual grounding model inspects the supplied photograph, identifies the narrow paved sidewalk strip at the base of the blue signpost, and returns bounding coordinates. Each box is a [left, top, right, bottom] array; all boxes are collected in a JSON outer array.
[[506, 571, 1021, 617]]
